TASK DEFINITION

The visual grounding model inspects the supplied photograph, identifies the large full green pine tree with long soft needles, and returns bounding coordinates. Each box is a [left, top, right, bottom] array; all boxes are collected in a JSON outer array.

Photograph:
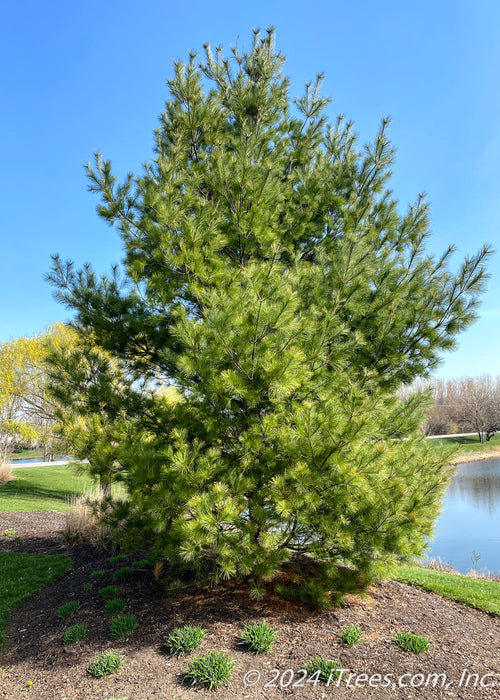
[[48, 31, 489, 605]]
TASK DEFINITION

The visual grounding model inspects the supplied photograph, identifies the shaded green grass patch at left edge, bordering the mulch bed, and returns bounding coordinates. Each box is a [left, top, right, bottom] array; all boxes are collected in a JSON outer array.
[[0, 552, 73, 648]]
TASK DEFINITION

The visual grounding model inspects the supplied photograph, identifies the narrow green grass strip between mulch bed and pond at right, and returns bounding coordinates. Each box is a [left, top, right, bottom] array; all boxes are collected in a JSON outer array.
[[395, 565, 500, 615]]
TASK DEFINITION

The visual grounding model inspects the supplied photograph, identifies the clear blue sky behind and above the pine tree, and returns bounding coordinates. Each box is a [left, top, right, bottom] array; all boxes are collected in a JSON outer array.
[[0, 0, 500, 377]]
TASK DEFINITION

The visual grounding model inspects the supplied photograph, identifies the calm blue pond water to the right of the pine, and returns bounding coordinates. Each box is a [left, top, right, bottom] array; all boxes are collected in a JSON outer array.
[[428, 459, 500, 574]]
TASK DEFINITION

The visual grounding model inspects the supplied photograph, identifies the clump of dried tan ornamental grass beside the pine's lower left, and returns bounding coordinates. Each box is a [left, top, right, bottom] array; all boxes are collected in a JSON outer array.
[[61, 491, 111, 547]]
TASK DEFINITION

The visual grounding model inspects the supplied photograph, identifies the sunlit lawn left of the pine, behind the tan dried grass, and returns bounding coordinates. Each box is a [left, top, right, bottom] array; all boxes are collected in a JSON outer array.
[[0, 464, 94, 513]]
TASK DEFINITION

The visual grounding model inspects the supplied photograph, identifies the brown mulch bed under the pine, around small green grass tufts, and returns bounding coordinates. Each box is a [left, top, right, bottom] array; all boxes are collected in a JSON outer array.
[[0, 512, 500, 700]]
